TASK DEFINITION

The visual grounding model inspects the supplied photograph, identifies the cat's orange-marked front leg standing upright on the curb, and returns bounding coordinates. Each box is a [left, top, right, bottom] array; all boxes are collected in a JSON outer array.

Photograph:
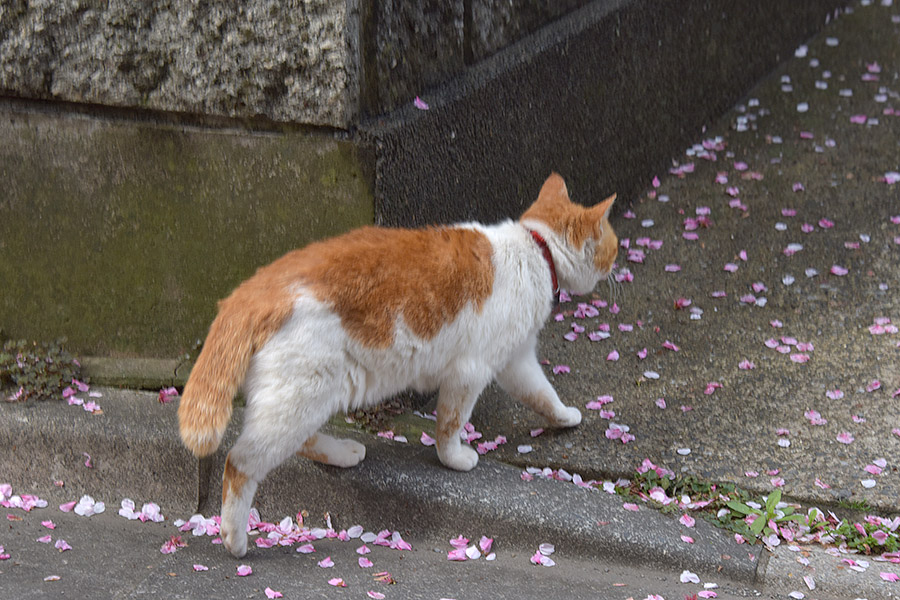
[[436, 384, 483, 471]]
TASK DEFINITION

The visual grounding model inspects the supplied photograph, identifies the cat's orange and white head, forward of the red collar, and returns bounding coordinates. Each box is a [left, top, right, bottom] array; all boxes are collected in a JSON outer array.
[[520, 173, 619, 294]]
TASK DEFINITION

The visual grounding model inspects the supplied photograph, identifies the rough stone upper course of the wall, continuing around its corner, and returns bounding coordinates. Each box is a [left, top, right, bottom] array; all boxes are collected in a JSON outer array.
[[0, 0, 588, 129]]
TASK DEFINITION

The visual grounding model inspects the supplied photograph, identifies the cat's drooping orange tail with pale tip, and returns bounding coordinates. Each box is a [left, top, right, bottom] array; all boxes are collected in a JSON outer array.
[[178, 280, 290, 458]]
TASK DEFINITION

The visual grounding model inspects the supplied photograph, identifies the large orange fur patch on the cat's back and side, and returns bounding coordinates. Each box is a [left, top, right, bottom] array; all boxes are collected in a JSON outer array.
[[267, 227, 494, 348]]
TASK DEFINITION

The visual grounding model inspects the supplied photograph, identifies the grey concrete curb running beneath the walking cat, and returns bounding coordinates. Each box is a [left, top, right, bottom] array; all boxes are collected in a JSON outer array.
[[0, 389, 760, 582]]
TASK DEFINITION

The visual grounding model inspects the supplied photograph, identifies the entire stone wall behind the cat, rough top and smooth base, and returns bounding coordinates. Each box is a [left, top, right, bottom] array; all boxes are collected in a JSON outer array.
[[0, 0, 848, 358]]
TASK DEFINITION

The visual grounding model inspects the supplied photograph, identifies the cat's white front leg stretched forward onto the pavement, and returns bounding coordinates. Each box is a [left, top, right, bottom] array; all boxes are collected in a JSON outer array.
[[496, 343, 581, 427]]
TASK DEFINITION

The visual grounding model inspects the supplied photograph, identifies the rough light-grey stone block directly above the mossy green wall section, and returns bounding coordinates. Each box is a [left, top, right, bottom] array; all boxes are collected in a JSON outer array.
[[0, 0, 359, 128]]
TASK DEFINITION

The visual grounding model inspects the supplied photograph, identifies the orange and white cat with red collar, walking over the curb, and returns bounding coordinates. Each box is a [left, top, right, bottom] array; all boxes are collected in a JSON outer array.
[[178, 174, 618, 557]]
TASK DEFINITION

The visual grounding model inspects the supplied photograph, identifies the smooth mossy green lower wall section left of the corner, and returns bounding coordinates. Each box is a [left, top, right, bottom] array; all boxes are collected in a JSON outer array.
[[0, 104, 373, 357]]
